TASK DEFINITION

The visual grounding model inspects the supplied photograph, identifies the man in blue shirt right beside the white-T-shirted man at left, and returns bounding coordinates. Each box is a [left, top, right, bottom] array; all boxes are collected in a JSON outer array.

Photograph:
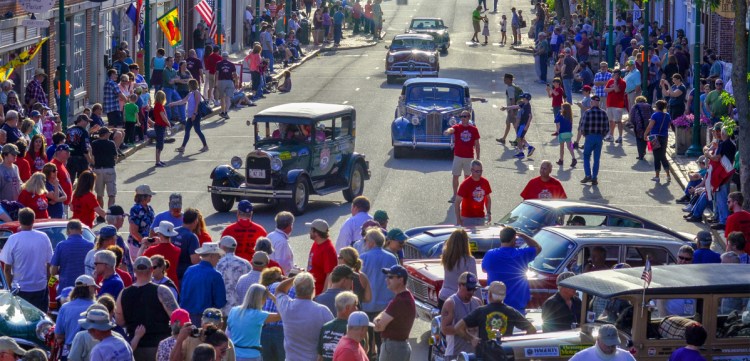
[[50, 219, 94, 290]]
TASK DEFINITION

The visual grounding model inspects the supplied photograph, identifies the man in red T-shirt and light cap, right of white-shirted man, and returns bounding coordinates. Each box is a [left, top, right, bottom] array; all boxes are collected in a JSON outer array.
[[305, 219, 338, 295]]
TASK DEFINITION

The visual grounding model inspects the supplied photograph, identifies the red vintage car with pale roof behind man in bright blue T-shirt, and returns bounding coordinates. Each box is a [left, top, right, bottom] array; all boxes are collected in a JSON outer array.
[[404, 226, 685, 321]]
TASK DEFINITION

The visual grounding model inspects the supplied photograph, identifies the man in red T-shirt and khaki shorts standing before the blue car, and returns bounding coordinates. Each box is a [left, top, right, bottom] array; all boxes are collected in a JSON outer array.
[[443, 110, 479, 203]]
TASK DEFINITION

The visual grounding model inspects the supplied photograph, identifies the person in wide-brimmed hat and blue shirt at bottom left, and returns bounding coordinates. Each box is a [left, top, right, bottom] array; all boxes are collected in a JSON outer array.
[[78, 308, 134, 361]]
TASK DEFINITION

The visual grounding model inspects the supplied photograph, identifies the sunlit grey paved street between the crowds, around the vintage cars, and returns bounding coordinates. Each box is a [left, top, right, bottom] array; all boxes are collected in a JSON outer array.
[[110, 0, 698, 360]]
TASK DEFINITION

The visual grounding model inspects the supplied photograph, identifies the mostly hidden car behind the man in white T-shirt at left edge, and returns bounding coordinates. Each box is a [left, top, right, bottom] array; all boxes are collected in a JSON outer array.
[[0, 219, 96, 316]]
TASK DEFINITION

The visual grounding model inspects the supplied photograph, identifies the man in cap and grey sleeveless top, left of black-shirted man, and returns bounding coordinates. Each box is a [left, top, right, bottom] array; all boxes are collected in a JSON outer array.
[[440, 272, 482, 360]]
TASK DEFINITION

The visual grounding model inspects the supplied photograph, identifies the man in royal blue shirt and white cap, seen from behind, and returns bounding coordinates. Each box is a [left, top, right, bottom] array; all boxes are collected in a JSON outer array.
[[180, 242, 227, 325]]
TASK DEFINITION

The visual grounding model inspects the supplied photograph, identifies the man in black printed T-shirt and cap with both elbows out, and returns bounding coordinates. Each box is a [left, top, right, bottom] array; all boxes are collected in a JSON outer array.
[[454, 281, 536, 359]]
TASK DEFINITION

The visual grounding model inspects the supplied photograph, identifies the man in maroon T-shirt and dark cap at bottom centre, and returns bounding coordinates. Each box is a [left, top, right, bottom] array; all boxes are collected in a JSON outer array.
[[373, 265, 417, 361]]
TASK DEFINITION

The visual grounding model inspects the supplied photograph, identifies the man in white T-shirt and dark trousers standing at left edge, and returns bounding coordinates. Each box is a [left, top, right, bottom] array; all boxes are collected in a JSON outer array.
[[0, 208, 53, 312]]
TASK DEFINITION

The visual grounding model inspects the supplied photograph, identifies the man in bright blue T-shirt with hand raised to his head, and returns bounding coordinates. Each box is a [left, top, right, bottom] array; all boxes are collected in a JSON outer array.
[[482, 227, 542, 314]]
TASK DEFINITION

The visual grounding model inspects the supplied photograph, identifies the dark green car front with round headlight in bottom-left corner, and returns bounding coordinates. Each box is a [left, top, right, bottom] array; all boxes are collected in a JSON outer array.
[[0, 272, 55, 350]]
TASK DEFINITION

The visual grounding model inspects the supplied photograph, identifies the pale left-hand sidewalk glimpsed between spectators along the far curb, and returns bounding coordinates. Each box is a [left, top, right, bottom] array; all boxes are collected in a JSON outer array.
[[117, 32, 385, 163]]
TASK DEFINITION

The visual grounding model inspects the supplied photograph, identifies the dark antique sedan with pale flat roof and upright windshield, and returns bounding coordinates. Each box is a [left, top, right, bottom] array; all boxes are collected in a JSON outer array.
[[208, 103, 370, 215]]
